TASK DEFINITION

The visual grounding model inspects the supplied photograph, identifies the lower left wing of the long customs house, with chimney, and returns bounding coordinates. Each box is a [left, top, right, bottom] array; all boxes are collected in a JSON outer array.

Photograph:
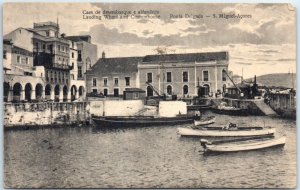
[[86, 53, 143, 97]]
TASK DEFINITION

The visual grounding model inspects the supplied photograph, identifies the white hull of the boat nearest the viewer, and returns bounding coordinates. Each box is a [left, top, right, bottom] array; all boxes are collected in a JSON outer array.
[[205, 137, 286, 153]]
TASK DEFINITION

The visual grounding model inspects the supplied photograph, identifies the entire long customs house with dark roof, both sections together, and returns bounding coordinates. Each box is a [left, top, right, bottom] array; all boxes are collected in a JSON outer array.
[[86, 52, 231, 98]]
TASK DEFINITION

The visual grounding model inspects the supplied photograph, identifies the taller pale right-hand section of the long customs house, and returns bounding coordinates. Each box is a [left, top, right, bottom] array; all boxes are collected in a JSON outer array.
[[138, 52, 228, 97]]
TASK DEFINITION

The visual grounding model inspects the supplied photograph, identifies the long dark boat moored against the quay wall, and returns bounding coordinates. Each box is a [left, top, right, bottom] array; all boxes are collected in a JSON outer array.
[[92, 115, 195, 127]]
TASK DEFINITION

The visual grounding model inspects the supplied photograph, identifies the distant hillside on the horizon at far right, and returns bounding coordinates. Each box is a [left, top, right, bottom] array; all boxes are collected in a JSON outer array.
[[245, 73, 297, 88]]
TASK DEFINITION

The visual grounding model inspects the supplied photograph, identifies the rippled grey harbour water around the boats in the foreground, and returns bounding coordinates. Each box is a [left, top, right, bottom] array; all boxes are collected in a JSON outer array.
[[4, 113, 296, 188]]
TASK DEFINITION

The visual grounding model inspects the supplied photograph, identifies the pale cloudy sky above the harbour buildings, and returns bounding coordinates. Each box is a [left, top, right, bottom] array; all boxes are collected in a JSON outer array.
[[3, 3, 296, 78]]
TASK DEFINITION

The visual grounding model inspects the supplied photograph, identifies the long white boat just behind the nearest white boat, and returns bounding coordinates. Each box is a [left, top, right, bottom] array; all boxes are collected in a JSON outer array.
[[177, 127, 276, 137]]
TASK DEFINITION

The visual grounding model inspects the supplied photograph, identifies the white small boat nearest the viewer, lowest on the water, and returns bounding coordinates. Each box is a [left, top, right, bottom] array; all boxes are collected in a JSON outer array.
[[200, 137, 286, 153]]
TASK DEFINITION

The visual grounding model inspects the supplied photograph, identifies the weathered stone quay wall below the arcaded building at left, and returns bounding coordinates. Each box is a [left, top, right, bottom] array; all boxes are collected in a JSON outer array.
[[4, 102, 90, 128]]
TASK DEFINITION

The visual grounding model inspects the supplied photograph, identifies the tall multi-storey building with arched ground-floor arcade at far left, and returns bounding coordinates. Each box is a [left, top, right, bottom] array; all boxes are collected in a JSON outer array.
[[3, 22, 93, 101]]
